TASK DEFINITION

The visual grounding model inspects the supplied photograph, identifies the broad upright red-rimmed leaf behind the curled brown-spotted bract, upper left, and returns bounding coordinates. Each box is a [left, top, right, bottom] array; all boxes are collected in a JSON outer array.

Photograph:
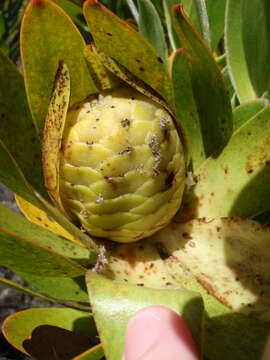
[[21, 0, 97, 133]]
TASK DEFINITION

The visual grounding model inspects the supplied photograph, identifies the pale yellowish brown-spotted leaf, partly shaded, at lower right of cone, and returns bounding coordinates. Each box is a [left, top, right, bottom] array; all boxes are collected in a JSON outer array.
[[154, 218, 270, 320]]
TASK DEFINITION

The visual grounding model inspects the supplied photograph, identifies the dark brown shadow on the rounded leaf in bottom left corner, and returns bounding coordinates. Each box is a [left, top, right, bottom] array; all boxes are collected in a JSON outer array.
[[23, 325, 93, 360]]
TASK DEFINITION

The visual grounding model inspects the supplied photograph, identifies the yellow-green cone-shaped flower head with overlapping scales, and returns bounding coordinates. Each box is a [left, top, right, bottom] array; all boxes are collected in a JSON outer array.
[[60, 88, 185, 242]]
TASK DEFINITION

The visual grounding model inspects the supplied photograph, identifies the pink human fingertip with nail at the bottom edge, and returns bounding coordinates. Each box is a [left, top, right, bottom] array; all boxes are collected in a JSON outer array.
[[124, 306, 200, 360]]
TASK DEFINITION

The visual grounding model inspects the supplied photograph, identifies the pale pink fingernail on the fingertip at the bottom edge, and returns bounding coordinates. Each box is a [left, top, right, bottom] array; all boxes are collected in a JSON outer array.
[[124, 307, 162, 360]]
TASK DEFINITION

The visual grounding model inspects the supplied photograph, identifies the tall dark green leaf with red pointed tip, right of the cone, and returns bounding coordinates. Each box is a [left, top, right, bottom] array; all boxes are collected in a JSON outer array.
[[173, 6, 232, 157]]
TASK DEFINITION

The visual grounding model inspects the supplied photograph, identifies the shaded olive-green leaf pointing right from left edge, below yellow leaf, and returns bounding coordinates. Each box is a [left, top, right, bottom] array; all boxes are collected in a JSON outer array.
[[0, 215, 85, 277]]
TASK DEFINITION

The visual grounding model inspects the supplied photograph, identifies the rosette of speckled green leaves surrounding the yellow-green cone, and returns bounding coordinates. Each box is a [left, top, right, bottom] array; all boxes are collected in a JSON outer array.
[[0, 0, 270, 360]]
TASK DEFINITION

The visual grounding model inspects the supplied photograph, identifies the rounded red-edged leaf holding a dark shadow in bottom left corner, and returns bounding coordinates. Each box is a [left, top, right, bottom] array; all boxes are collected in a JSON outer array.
[[2, 308, 96, 359]]
